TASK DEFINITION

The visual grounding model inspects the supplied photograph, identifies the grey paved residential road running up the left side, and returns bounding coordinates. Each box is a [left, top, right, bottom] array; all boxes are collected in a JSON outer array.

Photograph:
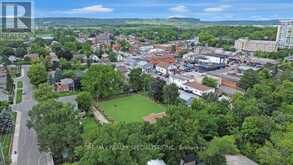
[[12, 66, 53, 165]]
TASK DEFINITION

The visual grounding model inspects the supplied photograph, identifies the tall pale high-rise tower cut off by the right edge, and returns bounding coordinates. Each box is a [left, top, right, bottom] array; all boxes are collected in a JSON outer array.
[[277, 20, 293, 48]]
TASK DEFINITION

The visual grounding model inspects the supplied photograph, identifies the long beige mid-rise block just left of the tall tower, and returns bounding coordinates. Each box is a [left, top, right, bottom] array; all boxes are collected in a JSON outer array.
[[234, 38, 278, 52]]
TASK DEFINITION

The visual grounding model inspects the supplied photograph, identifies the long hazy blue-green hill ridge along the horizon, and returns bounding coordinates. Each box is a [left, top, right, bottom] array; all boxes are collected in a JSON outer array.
[[35, 17, 279, 27]]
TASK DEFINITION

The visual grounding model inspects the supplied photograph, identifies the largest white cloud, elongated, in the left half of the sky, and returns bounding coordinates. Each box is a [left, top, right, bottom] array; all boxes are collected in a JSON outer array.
[[67, 5, 113, 14]]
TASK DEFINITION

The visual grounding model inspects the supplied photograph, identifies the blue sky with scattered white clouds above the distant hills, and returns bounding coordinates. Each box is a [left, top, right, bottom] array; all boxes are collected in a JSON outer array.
[[17, 0, 293, 21]]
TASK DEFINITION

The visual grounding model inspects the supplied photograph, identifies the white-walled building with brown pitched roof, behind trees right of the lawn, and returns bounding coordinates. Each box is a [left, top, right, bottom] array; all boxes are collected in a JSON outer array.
[[183, 81, 215, 96]]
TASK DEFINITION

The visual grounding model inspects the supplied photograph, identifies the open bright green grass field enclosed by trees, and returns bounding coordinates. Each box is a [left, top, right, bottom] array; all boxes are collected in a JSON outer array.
[[99, 95, 166, 123]]
